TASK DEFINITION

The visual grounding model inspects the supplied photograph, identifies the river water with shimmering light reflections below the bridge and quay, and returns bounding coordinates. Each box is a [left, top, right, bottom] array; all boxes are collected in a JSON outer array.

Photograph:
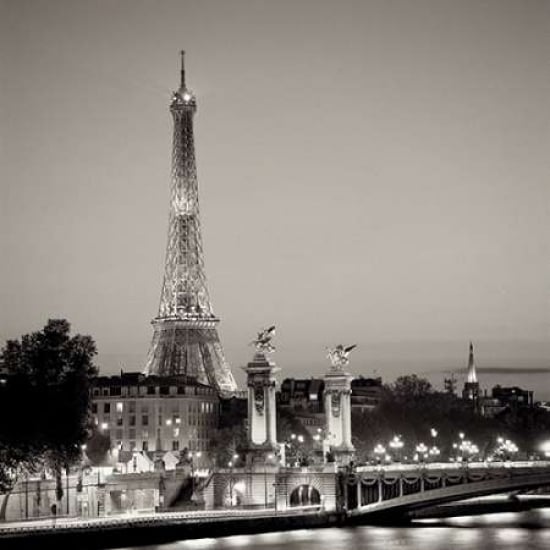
[[123, 508, 550, 550]]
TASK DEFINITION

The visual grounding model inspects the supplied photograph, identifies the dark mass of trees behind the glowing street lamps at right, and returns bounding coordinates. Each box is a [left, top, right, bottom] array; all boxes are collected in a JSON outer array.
[[352, 375, 550, 460]]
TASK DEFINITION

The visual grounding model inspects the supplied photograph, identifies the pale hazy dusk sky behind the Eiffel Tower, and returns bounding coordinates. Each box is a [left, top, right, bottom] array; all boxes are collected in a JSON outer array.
[[0, 0, 550, 399]]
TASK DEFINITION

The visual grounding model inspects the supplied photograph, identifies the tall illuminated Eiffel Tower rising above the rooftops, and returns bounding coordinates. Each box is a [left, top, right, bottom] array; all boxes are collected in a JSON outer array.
[[145, 52, 237, 394]]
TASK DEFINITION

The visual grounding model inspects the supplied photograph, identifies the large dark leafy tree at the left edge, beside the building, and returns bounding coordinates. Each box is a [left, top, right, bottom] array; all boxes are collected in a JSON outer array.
[[0, 319, 97, 518]]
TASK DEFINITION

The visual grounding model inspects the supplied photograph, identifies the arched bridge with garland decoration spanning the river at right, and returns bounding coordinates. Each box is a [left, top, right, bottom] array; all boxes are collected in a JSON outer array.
[[341, 461, 550, 523]]
